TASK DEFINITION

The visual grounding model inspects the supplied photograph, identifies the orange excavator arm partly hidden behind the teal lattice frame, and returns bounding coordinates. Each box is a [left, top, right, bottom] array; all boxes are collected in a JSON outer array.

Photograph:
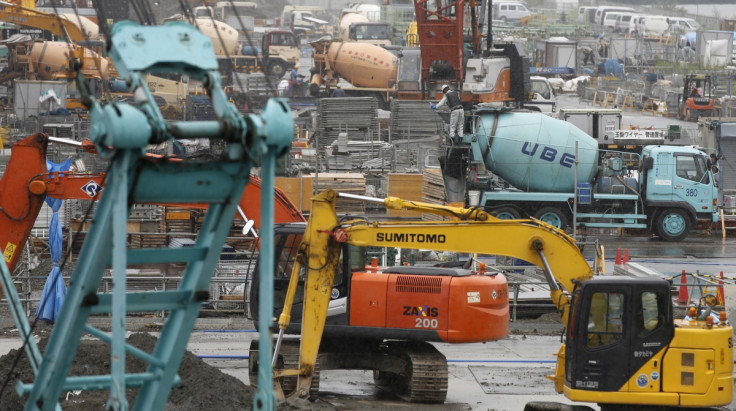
[[0, 133, 306, 272]]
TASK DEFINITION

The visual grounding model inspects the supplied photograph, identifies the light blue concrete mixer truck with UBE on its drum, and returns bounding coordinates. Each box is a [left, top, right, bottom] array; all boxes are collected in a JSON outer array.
[[440, 107, 719, 241]]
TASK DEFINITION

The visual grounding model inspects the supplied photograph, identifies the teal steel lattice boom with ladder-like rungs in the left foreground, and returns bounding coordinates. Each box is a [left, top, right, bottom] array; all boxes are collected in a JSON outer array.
[[13, 21, 293, 410]]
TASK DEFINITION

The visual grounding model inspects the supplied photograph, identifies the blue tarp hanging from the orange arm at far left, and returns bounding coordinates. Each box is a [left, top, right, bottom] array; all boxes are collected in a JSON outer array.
[[36, 158, 72, 323]]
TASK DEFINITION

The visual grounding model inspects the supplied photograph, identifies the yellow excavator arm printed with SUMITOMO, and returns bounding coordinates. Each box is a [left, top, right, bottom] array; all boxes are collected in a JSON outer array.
[[273, 190, 593, 397]]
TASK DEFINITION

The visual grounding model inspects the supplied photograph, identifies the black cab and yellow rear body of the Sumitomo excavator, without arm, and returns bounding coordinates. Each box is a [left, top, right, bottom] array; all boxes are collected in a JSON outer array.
[[558, 276, 733, 409]]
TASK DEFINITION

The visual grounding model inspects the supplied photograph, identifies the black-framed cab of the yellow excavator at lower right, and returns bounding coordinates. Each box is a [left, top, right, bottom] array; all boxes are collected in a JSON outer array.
[[565, 277, 674, 392]]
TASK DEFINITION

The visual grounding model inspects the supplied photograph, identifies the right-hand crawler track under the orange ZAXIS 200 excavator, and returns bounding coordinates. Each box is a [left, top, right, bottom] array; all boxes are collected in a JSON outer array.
[[374, 341, 448, 403]]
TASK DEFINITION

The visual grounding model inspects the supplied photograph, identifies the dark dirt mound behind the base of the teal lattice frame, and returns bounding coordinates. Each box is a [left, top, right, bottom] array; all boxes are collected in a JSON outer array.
[[0, 333, 254, 411]]
